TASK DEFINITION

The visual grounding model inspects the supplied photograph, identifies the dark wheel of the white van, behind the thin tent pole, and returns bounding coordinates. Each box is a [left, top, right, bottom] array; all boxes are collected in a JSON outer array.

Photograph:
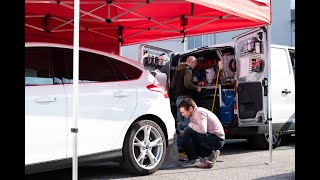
[[252, 132, 282, 150]]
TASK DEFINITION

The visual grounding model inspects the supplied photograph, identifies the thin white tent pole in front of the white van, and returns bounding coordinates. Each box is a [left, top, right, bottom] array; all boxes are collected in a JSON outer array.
[[267, 25, 272, 164]]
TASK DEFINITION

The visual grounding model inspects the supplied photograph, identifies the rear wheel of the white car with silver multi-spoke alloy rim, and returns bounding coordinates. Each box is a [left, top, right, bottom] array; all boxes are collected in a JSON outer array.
[[120, 120, 166, 175]]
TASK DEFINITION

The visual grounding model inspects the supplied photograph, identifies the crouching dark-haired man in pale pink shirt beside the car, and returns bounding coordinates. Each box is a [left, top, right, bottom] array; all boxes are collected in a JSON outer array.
[[178, 98, 225, 164]]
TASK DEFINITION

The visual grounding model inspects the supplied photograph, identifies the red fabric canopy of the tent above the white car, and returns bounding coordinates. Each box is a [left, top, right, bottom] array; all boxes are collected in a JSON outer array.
[[25, 0, 271, 54]]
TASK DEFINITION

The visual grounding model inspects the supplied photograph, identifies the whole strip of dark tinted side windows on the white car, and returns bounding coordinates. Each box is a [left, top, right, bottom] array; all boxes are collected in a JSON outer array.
[[25, 47, 142, 84]]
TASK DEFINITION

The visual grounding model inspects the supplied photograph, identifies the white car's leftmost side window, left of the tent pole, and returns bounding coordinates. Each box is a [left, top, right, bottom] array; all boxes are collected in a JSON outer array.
[[25, 48, 54, 85]]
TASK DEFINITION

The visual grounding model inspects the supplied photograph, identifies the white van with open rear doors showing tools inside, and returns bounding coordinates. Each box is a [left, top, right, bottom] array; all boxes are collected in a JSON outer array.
[[139, 27, 295, 149]]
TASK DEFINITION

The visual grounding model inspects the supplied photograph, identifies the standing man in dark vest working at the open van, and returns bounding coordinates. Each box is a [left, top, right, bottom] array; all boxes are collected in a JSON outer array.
[[171, 56, 201, 152]]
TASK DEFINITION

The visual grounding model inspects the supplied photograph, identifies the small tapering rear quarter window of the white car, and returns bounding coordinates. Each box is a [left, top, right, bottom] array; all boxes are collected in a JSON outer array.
[[113, 60, 142, 80]]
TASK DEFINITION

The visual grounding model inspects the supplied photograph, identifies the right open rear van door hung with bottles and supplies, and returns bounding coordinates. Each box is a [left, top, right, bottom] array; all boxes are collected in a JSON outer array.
[[235, 27, 268, 127]]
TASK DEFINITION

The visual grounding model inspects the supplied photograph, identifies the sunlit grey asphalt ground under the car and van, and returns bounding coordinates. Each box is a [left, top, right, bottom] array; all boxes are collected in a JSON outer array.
[[25, 137, 295, 180]]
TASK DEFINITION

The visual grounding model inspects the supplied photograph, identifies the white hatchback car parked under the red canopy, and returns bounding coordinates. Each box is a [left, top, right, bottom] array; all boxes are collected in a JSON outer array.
[[25, 43, 175, 175]]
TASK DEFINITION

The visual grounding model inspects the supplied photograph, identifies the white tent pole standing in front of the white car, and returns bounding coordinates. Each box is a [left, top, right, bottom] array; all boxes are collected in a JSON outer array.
[[71, 0, 80, 180]]
